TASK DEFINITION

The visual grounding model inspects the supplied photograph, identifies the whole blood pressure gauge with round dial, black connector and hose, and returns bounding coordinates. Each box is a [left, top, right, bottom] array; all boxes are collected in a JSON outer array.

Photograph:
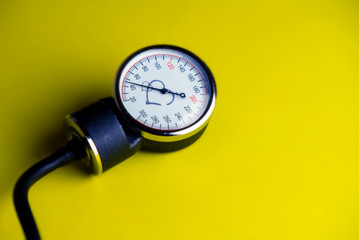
[[14, 45, 216, 239]]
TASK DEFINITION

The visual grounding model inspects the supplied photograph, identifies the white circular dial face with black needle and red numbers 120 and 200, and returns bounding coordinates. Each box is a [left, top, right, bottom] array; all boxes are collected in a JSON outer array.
[[115, 48, 212, 131]]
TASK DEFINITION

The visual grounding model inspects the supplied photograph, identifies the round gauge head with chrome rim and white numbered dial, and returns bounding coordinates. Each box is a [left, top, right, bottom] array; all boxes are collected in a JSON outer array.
[[115, 45, 216, 148]]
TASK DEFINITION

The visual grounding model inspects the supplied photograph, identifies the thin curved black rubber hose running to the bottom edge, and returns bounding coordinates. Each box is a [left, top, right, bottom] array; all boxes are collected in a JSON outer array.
[[14, 138, 86, 240]]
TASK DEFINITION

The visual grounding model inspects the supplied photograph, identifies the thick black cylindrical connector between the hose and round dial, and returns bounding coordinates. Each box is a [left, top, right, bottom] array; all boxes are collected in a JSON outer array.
[[71, 98, 142, 172]]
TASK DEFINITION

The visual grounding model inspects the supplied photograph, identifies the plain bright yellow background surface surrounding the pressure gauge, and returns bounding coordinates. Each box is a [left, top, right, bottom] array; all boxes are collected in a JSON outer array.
[[0, 0, 359, 240]]
